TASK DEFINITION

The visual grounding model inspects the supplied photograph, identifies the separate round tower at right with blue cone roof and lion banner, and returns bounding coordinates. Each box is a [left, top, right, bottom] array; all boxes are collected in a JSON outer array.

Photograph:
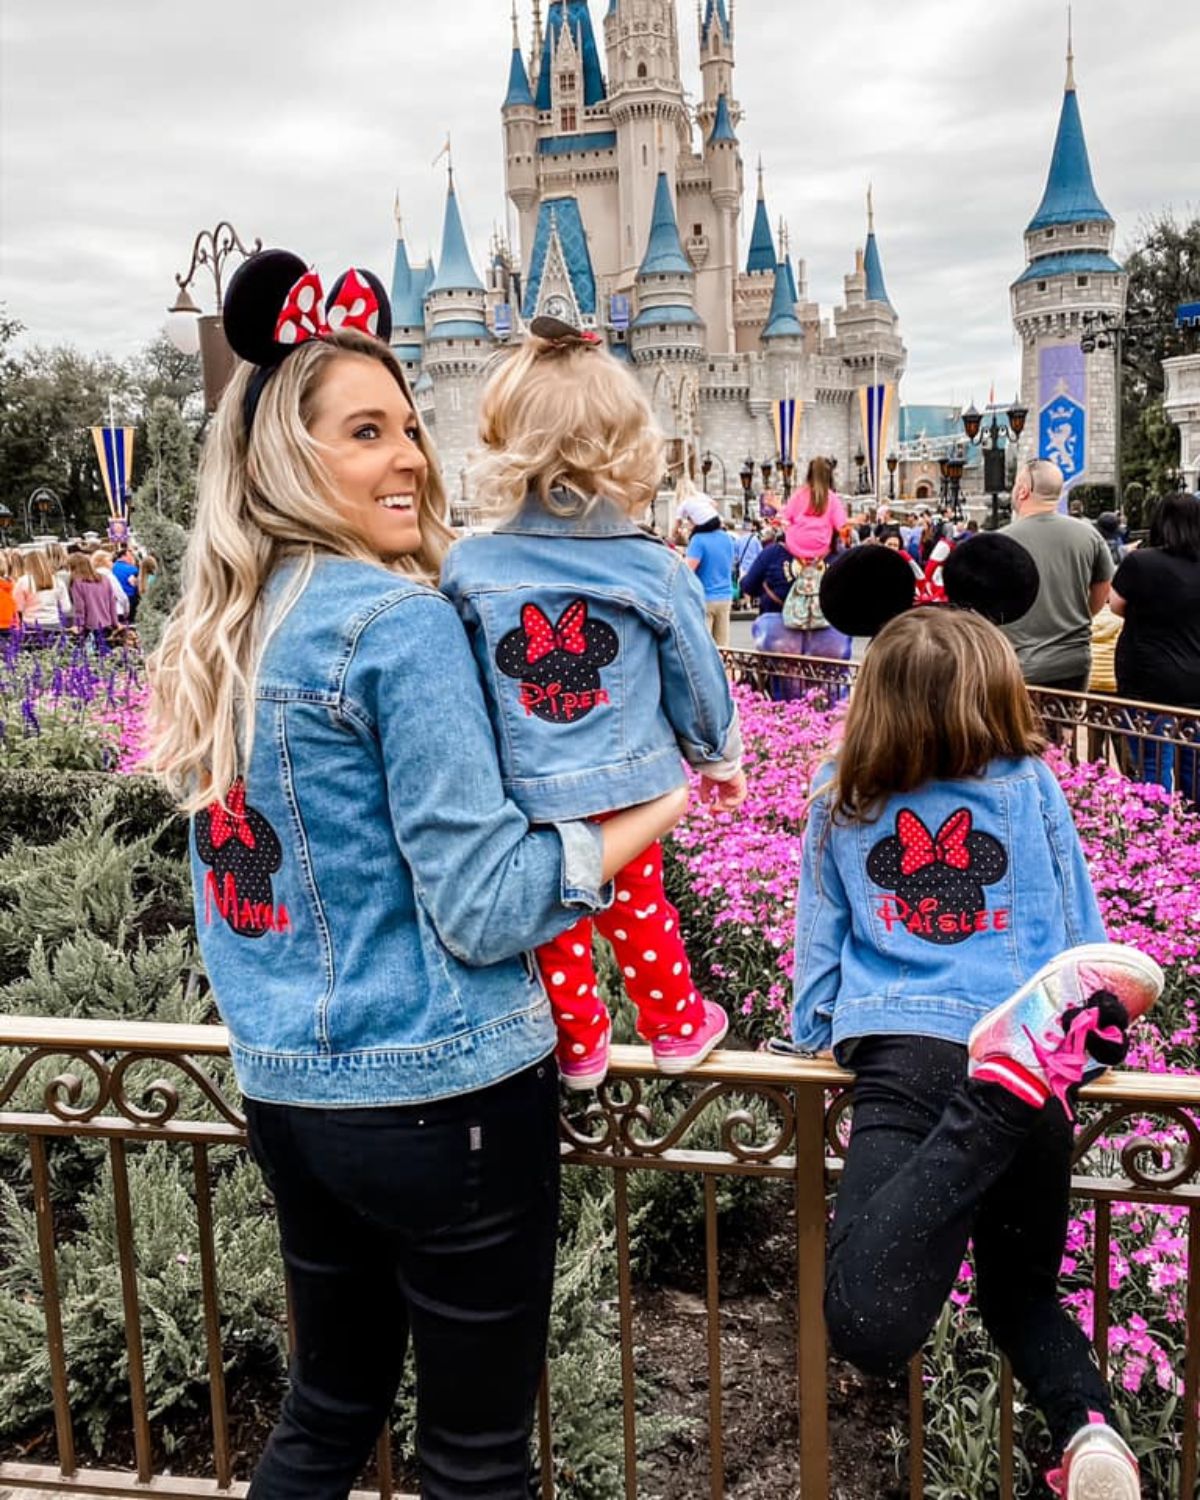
[[1011, 32, 1128, 500]]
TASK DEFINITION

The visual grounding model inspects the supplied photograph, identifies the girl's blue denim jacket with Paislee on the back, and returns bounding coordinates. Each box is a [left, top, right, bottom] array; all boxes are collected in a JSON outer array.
[[792, 759, 1106, 1061]]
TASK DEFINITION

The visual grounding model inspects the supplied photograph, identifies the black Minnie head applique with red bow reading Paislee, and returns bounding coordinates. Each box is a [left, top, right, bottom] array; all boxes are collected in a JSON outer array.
[[867, 807, 1008, 945]]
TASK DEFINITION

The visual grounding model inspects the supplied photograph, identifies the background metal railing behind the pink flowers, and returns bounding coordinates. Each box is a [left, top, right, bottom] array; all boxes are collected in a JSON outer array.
[[722, 651, 1200, 801]]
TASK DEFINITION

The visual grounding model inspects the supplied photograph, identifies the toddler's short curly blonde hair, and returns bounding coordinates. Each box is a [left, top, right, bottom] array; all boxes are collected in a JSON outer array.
[[471, 336, 663, 519]]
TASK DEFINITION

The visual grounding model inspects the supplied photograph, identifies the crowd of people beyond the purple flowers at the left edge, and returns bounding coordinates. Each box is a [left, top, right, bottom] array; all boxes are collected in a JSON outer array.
[[0, 536, 158, 645]]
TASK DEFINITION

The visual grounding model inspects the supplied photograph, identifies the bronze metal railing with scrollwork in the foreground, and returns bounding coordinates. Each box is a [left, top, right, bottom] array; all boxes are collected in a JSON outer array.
[[0, 1017, 1200, 1500]]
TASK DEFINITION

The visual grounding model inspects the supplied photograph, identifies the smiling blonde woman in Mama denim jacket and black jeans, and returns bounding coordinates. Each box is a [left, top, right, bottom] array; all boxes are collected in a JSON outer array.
[[153, 251, 683, 1500]]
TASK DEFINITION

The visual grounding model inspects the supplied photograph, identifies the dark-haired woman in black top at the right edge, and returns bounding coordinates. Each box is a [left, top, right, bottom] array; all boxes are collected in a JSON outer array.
[[1109, 495, 1200, 803]]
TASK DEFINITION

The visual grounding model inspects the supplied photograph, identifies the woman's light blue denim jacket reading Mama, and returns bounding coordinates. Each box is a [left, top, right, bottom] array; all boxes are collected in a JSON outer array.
[[192, 558, 612, 1106]]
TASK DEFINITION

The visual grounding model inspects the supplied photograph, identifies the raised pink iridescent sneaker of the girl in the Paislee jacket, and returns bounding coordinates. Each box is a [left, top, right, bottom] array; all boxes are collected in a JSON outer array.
[[968, 942, 1163, 1119]]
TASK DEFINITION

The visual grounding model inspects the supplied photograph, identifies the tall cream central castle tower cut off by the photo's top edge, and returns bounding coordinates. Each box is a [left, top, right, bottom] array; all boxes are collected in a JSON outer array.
[[605, 0, 690, 291]]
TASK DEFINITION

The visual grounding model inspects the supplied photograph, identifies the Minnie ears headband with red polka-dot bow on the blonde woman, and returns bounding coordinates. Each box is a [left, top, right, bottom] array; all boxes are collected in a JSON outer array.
[[224, 251, 392, 434]]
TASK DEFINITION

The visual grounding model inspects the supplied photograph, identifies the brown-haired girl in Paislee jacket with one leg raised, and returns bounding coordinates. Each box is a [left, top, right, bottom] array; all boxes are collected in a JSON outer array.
[[792, 536, 1163, 1500]]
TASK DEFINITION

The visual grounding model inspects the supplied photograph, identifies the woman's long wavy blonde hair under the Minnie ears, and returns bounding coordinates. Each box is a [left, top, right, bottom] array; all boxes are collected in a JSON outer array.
[[147, 330, 453, 813]]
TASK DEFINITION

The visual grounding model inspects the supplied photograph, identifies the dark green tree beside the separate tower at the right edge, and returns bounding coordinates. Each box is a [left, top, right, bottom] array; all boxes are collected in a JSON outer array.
[[1121, 210, 1200, 494]]
